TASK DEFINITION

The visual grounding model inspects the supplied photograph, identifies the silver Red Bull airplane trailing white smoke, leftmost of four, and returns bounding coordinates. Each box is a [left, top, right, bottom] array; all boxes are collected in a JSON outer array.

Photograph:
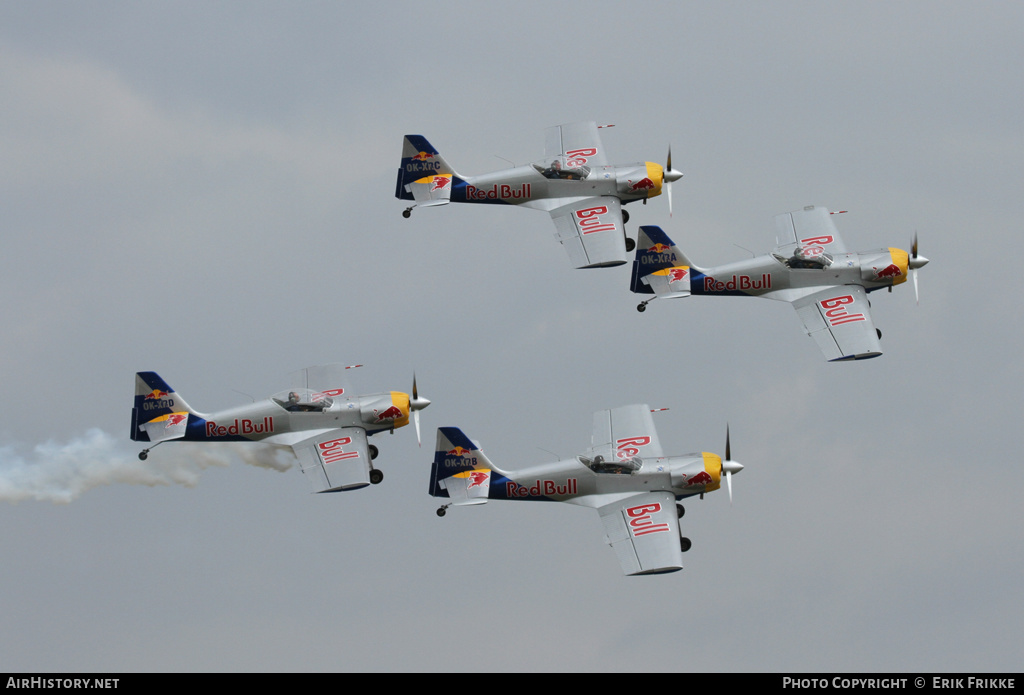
[[131, 364, 430, 492]]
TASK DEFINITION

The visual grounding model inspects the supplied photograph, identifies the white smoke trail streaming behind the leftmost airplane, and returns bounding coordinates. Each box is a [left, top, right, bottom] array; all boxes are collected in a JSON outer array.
[[0, 429, 295, 503]]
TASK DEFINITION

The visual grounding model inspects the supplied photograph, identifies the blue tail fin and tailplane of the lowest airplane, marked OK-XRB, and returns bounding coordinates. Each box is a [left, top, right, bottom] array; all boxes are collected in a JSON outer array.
[[430, 427, 500, 505]]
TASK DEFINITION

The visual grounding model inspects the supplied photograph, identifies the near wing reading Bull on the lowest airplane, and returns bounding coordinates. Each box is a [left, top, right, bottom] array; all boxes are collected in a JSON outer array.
[[597, 490, 683, 574]]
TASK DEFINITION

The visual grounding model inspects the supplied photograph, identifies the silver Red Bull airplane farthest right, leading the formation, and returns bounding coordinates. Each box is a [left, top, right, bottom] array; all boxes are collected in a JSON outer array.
[[630, 206, 928, 361]]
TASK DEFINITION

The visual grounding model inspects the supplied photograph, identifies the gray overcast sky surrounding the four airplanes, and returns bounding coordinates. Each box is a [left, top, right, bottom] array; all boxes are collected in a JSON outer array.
[[0, 1, 1024, 671]]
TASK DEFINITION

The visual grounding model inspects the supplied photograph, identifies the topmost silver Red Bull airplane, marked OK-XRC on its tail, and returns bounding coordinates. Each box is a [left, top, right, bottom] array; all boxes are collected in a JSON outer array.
[[394, 122, 683, 268]]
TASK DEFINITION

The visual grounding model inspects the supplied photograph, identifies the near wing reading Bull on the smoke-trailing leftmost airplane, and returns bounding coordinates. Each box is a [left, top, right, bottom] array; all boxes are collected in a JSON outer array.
[[292, 427, 371, 492]]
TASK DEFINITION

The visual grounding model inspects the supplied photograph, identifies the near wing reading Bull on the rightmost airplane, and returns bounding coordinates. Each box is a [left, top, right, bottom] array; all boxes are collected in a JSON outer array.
[[793, 285, 882, 361]]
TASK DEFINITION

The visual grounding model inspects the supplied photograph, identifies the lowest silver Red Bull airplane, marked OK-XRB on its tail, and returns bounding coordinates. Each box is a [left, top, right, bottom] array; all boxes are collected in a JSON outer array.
[[430, 404, 743, 575]]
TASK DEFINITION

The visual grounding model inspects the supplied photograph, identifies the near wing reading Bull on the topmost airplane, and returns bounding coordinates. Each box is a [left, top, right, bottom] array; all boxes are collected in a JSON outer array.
[[551, 196, 626, 268]]
